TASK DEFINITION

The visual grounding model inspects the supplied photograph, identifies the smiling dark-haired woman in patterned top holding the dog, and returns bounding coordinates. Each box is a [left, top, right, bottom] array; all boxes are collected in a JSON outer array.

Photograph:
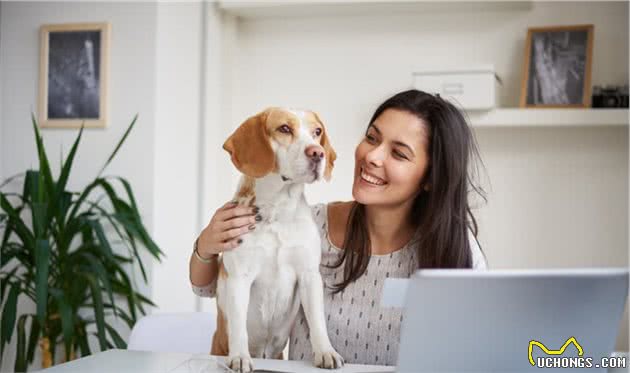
[[190, 90, 486, 365]]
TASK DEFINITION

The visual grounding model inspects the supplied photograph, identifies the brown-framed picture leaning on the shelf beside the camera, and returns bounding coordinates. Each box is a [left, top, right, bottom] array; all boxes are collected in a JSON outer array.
[[520, 25, 593, 108]]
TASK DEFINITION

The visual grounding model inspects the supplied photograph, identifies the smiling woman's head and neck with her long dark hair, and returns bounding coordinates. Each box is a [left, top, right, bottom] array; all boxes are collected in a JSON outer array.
[[330, 90, 492, 292]]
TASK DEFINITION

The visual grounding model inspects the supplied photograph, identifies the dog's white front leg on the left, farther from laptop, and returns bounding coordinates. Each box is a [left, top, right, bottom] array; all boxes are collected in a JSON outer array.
[[225, 275, 253, 373]]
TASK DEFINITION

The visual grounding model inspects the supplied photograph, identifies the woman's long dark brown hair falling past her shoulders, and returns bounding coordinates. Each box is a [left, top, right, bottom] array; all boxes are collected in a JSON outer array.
[[330, 90, 487, 293]]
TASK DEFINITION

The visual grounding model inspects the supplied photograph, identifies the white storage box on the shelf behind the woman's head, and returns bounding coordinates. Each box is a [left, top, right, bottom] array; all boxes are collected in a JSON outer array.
[[413, 66, 500, 110]]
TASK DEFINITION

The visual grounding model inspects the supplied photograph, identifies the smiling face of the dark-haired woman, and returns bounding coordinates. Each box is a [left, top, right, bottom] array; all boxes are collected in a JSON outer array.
[[352, 109, 429, 206]]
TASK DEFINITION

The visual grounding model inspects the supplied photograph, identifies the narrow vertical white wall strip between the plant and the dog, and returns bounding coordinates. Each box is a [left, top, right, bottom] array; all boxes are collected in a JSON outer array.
[[151, 3, 204, 312]]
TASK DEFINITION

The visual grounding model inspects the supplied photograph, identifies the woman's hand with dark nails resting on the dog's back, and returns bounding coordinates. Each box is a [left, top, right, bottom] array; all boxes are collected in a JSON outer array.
[[197, 202, 261, 258]]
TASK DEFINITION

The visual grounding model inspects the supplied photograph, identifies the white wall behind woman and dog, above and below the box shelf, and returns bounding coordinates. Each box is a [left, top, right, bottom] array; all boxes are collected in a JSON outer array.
[[226, 2, 628, 350]]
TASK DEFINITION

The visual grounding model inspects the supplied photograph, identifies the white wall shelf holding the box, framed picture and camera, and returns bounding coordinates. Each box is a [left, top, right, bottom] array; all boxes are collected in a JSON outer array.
[[468, 108, 629, 127]]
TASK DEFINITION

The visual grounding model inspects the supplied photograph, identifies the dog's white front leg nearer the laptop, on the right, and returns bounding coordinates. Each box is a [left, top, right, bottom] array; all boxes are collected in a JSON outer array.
[[299, 270, 344, 369]]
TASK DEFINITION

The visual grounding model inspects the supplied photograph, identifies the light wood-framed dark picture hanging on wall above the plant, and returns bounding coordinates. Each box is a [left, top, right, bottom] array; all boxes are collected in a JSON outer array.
[[39, 23, 110, 128]]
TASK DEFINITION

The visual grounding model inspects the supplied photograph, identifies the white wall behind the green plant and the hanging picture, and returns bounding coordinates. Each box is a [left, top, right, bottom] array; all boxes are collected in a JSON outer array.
[[0, 2, 160, 371]]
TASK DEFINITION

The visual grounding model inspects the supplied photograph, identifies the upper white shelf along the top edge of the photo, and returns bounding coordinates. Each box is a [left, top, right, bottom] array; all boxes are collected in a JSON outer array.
[[217, 0, 533, 19]]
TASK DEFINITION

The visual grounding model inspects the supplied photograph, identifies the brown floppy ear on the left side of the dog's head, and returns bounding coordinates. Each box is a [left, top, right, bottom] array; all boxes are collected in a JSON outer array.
[[223, 110, 276, 178]]
